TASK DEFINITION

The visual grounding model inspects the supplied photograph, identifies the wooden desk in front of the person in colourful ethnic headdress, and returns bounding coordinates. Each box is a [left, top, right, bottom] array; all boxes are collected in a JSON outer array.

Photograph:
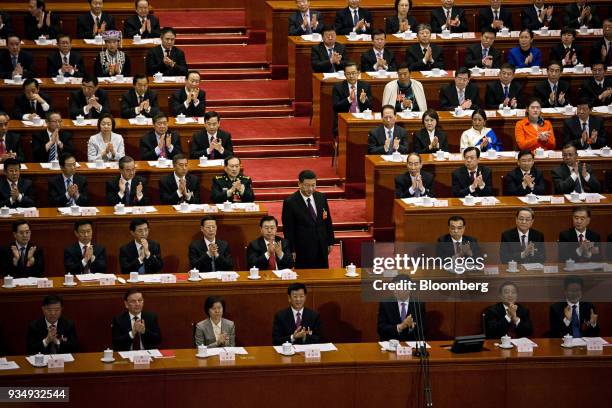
[[0, 77, 183, 119]]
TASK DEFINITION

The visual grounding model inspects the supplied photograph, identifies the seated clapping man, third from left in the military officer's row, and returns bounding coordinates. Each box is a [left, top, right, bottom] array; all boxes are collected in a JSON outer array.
[[106, 156, 150, 206]]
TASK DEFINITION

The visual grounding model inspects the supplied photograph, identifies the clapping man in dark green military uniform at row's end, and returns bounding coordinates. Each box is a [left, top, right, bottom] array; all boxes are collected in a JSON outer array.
[[210, 156, 255, 204]]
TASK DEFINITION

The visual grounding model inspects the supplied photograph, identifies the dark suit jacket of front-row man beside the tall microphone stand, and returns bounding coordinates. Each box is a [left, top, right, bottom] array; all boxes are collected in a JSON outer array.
[[377, 301, 427, 341]]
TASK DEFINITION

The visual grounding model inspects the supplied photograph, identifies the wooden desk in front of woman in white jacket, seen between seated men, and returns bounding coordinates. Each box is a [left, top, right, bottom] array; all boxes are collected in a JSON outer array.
[[21, 160, 223, 207]]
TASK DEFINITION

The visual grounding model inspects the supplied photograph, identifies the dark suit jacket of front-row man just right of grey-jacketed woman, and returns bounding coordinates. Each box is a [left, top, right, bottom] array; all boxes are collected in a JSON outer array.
[[272, 307, 323, 346]]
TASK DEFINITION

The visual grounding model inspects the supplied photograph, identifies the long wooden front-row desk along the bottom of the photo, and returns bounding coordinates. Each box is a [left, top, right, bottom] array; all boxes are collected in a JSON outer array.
[[0, 338, 612, 408]]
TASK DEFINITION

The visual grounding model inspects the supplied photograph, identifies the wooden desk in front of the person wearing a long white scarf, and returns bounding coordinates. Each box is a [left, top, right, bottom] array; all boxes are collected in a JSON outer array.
[[338, 111, 612, 191]]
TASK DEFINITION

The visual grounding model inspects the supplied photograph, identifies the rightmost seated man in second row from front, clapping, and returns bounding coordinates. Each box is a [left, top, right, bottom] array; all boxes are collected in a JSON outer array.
[[559, 207, 602, 262]]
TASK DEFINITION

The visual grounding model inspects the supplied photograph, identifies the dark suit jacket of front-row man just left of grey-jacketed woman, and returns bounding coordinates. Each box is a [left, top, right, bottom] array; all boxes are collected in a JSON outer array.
[[111, 310, 161, 351]]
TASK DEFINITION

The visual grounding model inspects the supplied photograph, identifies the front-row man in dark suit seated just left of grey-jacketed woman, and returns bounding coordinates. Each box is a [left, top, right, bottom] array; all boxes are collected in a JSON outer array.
[[111, 288, 161, 351]]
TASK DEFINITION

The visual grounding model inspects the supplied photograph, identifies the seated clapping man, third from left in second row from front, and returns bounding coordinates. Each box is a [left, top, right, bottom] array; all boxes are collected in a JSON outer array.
[[119, 218, 164, 275]]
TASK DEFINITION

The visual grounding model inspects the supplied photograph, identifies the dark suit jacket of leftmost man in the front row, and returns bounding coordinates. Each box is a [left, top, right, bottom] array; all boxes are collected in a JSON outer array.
[[26, 317, 79, 355]]
